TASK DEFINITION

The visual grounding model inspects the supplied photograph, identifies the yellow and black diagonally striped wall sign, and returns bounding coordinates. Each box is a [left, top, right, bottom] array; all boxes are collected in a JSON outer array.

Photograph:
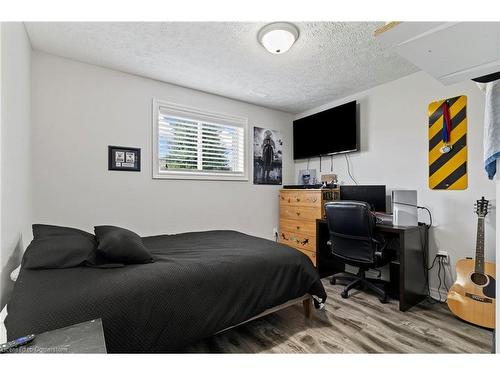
[[429, 95, 467, 190]]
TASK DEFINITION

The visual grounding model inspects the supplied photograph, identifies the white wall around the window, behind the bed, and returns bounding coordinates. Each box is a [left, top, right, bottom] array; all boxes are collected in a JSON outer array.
[[32, 52, 294, 238]]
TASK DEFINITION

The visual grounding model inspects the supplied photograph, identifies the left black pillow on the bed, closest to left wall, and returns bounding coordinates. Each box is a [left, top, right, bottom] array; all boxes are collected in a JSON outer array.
[[23, 233, 96, 269]]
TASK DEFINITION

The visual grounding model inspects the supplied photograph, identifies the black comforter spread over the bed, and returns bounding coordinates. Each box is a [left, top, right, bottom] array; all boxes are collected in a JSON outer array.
[[5, 231, 326, 352]]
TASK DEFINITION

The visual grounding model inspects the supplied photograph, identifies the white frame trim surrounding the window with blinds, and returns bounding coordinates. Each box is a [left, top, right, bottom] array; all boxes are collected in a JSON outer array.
[[152, 98, 249, 181]]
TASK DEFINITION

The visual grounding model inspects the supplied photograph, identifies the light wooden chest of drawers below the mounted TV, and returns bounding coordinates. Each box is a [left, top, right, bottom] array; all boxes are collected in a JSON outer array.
[[279, 189, 339, 265]]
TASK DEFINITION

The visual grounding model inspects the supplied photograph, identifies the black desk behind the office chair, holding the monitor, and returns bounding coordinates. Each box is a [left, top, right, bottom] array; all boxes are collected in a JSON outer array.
[[316, 219, 429, 311]]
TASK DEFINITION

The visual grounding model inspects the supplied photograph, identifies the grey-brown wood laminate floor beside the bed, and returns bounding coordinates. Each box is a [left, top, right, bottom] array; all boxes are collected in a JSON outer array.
[[183, 279, 493, 353]]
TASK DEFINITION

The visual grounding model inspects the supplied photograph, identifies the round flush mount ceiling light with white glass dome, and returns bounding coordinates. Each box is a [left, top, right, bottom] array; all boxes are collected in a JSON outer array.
[[257, 22, 299, 55]]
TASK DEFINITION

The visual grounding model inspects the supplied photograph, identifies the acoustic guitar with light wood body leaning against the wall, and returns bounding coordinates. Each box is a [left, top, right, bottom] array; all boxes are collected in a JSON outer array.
[[448, 197, 495, 328]]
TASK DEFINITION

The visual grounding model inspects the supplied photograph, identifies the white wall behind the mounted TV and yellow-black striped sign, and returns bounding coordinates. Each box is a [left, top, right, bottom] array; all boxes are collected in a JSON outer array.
[[295, 72, 496, 296]]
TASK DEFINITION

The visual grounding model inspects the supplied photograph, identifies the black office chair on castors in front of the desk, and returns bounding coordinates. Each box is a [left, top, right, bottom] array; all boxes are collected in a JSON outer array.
[[325, 201, 391, 303]]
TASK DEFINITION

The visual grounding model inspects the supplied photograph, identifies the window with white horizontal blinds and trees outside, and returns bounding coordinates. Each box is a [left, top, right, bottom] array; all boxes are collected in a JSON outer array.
[[153, 100, 248, 180]]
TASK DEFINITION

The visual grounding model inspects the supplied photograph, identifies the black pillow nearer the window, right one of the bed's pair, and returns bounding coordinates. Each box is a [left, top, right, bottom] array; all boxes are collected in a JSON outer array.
[[94, 225, 153, 264]]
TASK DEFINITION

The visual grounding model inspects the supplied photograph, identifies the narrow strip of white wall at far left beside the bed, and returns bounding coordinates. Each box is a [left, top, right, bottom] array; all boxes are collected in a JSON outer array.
[[0, 22, 32, 309]]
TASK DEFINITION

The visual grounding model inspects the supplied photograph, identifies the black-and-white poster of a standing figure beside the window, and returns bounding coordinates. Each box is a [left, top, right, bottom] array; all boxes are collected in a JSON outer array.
[[253, 127, 283, 185]]
